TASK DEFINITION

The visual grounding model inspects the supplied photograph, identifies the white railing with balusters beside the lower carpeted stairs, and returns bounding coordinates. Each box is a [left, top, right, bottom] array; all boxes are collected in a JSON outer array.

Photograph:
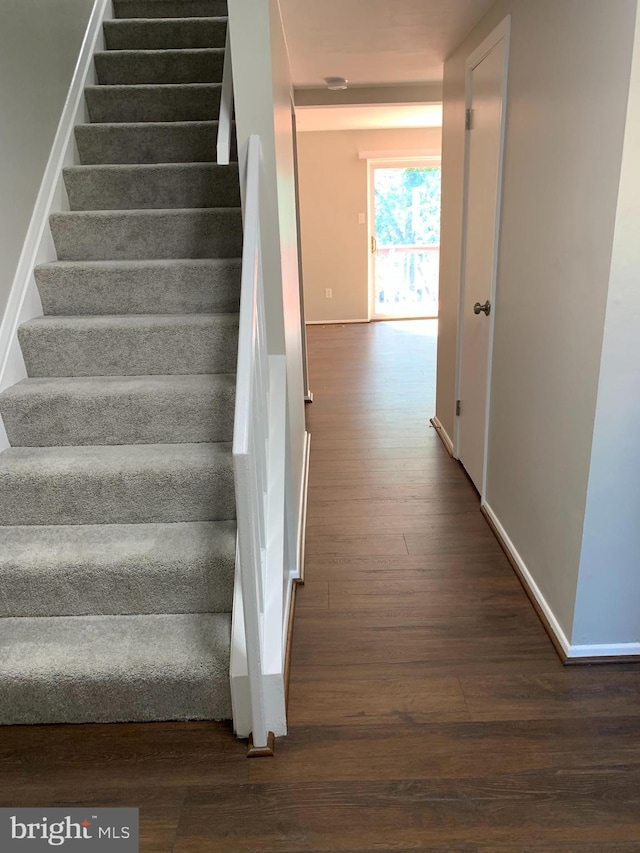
[[232, 136, 286, 749]]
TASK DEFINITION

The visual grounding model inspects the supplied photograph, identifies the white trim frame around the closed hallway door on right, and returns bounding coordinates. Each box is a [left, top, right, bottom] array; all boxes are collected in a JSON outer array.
[[453, 15, 511, 505]]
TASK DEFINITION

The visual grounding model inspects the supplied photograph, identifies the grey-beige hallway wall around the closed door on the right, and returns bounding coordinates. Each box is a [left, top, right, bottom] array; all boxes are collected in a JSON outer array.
[[437, 0, 636, 638]]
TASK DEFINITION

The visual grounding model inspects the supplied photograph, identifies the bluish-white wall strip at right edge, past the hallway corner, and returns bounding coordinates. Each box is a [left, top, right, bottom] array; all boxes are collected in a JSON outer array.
[[573, 6, 640, 654]]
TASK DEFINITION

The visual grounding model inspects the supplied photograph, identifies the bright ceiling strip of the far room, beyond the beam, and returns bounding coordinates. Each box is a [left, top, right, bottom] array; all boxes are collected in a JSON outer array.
[[296, 104, 442, 132]]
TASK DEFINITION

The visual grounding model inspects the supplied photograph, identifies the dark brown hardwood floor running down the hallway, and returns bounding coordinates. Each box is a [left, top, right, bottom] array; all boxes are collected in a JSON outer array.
[[0, 322, 640, 853]]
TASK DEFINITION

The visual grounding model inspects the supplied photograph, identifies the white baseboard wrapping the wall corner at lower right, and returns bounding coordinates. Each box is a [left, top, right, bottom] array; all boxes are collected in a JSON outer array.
[[482, 502, 640, 663]]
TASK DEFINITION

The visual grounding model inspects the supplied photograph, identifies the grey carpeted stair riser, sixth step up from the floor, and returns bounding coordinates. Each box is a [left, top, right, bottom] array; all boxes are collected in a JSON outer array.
[[35, 259, 240, 315]]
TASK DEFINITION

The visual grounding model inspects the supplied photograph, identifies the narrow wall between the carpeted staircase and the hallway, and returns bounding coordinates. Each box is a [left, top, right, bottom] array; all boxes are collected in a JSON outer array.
[[228, 0, 305, 564]]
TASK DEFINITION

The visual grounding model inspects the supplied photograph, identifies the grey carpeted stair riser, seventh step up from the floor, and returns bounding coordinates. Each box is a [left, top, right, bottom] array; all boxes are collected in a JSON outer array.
[[50, 209, 242, 261]]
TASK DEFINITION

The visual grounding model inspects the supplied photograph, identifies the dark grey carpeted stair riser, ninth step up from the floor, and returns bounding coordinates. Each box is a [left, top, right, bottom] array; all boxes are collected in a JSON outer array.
[[75, 122, 237, 165]]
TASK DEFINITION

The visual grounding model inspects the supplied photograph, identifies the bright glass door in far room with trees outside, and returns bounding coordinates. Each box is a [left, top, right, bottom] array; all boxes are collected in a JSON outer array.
[[369, 157, 441, 320]]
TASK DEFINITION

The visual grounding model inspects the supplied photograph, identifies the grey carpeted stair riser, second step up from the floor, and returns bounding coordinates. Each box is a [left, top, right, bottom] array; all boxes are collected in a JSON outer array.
[[0, 523, 235, 618]]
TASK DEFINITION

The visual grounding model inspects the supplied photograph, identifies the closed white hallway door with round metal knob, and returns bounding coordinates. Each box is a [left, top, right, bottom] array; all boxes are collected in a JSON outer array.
[[457, 23, 507, 494]]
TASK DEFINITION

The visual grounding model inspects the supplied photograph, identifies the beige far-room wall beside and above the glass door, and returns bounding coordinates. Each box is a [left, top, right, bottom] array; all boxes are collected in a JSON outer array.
[[298, 127, 441, 323]]
